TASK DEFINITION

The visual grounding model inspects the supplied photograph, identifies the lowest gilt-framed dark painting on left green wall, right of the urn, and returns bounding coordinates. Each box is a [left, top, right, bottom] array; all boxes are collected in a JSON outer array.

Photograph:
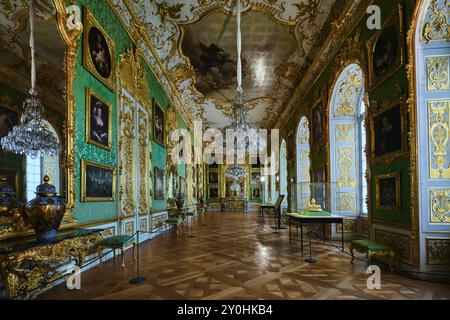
[[80, 159, 116, 202]]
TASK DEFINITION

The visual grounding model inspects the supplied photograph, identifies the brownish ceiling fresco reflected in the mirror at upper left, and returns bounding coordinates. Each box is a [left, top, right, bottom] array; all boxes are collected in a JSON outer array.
[[0, 0, 66, 112]]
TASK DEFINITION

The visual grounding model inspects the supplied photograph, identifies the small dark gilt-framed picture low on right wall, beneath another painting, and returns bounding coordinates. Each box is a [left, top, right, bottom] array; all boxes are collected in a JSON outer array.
[[375, 172, 401, 212]]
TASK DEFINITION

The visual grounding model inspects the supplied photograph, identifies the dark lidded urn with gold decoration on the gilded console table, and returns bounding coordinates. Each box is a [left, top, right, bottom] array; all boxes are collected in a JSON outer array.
[[24, 176, 66, 242]]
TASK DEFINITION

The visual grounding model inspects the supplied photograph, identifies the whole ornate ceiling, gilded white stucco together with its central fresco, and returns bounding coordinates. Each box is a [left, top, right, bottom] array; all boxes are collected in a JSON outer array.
[[109, 0, 366, 127]]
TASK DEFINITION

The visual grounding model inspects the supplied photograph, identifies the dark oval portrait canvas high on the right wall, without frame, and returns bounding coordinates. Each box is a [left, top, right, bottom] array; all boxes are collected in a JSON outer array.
[[373, 26, 399, 76]]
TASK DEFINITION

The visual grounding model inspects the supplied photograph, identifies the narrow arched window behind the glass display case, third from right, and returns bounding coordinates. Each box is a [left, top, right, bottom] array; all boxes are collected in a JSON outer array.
[[297, 117, 311, 210]]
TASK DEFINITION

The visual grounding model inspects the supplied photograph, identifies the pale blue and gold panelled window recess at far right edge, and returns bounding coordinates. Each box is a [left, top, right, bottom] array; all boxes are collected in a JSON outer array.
[[411, 0, 450, 269]]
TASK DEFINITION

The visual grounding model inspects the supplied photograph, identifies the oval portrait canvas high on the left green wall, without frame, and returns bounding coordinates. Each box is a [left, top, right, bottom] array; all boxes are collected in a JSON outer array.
[[89, 27, 111, 78]]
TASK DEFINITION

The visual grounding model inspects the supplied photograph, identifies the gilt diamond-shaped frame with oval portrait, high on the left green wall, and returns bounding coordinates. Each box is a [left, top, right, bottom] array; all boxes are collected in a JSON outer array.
[[83, 7, 116, 91]]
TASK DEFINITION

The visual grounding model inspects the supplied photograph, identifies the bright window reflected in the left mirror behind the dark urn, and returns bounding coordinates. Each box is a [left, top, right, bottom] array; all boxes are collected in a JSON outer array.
[[26, 120, 60, 201]]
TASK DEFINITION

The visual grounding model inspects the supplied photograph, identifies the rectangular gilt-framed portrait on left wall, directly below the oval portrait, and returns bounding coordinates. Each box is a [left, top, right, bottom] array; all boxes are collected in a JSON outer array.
[[86, 88, 112, 151]]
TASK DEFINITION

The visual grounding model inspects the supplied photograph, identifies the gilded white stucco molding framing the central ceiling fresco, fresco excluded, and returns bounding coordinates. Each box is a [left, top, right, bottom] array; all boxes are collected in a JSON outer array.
[[109, 0, 348, 126]]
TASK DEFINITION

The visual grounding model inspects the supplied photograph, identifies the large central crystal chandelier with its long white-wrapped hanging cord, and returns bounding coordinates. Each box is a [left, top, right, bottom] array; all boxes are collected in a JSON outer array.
[[223, 0, 266, 159]]
